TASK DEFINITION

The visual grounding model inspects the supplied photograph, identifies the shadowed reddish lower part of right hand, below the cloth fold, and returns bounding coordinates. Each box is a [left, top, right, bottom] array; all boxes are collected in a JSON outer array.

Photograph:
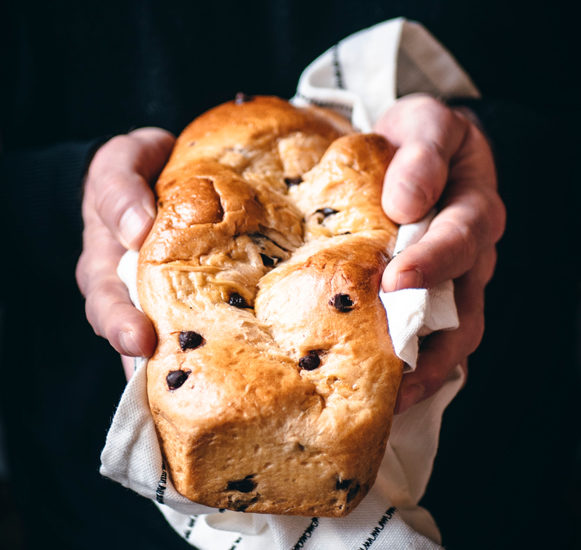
[[396, 249, 495, 414]]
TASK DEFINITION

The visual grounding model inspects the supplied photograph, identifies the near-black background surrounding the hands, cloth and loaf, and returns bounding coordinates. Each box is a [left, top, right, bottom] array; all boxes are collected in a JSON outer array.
[[0, 0, 581, 549]]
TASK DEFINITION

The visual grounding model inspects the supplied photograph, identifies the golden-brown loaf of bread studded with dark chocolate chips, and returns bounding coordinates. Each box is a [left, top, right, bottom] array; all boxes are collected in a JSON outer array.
[[138, 96, 402, 516]]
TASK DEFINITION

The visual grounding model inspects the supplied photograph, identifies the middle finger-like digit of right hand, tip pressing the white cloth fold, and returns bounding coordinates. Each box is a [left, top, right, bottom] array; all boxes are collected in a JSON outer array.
[[382, 185, 505, 292]]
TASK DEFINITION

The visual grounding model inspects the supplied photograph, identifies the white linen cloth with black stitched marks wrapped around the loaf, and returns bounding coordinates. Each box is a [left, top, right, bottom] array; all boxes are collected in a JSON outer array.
[[100, 18, 478, 550]]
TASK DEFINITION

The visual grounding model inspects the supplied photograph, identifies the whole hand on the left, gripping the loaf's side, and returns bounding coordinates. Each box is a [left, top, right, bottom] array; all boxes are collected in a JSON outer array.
[[76, 128, 175, 379]]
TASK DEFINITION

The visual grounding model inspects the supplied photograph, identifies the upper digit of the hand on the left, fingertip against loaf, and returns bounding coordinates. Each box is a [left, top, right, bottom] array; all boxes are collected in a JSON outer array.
[[87, 128, 174, 249]]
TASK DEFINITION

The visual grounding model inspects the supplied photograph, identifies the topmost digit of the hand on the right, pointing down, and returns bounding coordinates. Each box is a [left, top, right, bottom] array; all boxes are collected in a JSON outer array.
[[375, 96, 469, 223]]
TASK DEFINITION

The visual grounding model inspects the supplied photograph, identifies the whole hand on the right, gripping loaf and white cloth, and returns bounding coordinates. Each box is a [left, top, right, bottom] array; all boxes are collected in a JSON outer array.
[[375, 94, 506, 413]]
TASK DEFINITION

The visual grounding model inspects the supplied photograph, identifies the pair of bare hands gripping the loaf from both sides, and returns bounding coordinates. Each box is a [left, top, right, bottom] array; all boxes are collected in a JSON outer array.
[[76, 95, 505, 412]]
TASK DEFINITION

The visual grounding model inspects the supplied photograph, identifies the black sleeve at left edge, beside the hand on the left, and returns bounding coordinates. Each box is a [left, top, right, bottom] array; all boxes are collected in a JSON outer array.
[[0, 138, 103, 294]]
